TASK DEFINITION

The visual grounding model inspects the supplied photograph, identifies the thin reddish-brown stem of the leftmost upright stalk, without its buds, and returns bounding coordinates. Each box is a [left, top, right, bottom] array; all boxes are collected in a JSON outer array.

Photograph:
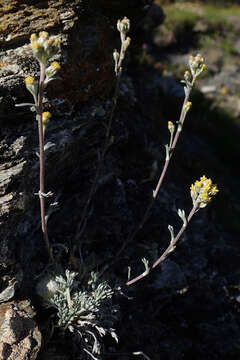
[[36, 62, 54, 261]]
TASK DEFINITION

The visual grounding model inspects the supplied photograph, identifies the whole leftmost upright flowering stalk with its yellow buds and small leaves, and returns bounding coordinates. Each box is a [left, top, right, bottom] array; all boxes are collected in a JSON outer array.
[[16, 31, 60, 261]]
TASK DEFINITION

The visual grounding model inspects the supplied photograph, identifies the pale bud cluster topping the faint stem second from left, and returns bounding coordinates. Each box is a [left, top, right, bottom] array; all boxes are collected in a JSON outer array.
[[113, 16, 131, 75]]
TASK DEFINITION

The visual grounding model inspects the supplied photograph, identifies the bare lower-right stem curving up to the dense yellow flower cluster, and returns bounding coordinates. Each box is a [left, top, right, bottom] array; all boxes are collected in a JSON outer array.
[[122, 202, 199, 290]]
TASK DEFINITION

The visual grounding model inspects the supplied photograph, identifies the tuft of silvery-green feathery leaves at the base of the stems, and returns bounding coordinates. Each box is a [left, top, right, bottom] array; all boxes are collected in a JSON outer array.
[[49, 270, 118, 358]]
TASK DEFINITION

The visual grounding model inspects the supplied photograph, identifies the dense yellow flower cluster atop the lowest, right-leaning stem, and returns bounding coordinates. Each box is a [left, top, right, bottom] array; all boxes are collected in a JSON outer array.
[[190, 175, 219, 208]]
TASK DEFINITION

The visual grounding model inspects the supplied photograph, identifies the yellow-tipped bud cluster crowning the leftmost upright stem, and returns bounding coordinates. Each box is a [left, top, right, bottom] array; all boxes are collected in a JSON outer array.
[[30, 31, 60, 65]]
